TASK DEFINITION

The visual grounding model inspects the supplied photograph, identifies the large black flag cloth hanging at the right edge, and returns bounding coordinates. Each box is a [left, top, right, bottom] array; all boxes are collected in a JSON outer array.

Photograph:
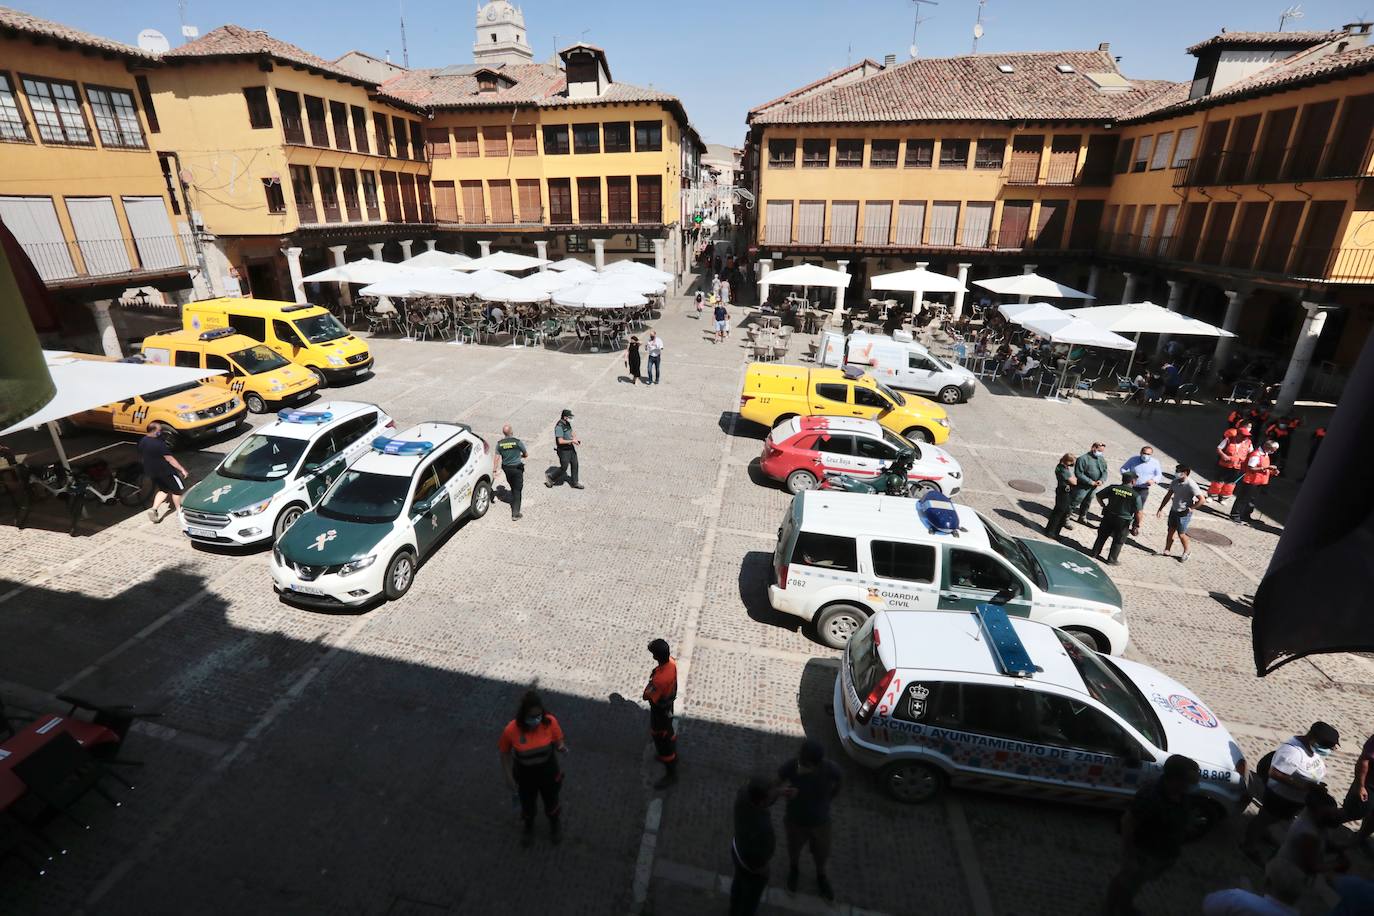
[[1250, 335, 1374, 676]]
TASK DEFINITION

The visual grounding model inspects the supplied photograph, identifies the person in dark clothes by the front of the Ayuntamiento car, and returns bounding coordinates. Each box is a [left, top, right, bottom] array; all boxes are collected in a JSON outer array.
[[1106, 754, 1202, 916]]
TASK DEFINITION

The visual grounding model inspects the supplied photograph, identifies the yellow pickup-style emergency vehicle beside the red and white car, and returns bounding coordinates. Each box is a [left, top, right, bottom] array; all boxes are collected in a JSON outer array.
[[739, 363, 949, 445]]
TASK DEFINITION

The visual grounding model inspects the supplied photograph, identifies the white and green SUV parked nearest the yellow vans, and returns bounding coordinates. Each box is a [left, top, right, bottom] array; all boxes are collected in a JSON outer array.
[[181, 401, 396, 545]]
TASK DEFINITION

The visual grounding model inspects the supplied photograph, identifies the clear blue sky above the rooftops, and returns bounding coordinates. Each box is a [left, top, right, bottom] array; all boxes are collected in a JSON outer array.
[[21, 0, 1374, 146]]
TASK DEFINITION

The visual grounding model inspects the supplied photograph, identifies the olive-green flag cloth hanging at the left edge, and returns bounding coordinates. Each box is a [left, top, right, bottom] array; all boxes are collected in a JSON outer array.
[[0, 222, 56, 430]]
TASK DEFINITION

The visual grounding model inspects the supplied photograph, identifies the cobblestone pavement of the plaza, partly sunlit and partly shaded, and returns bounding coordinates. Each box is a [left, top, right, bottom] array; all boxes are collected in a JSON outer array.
[[0, 302, 1371, 916]]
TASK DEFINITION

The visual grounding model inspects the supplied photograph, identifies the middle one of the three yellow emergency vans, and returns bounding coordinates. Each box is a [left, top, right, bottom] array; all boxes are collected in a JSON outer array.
[[143, 328, 317, 413]]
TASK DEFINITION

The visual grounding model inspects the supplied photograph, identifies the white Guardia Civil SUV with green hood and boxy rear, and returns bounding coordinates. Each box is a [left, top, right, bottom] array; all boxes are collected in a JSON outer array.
[[768, 490, 1129, 655]]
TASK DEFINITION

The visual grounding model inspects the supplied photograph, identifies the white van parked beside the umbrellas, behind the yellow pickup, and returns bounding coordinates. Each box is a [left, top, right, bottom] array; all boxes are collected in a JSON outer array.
[[816, 331, 977, 404]]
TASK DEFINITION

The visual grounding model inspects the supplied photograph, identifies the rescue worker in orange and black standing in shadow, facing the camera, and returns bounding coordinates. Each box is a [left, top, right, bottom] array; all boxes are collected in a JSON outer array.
[[497, 691, 567, 846]]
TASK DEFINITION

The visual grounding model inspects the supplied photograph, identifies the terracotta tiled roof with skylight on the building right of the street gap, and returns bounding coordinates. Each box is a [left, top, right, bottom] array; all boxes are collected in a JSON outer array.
[[752, 51, 1173, 124]]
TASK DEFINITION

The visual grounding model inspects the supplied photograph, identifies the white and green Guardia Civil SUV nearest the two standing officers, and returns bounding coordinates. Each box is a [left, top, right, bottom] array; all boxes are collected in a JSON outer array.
[[272, 423, 492, 607]]
